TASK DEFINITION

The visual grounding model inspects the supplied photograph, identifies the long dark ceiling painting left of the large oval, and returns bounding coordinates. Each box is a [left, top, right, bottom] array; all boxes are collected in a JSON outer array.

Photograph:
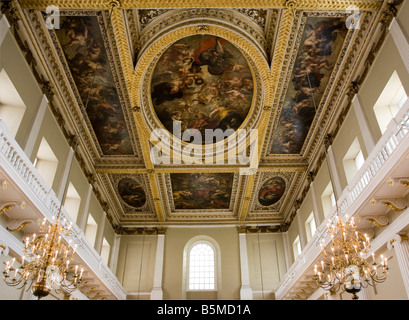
[[56, 16, 133, 155]]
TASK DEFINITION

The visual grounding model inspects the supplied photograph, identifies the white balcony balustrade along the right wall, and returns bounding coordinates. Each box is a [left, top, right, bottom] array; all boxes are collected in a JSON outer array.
[[275, 99, 409, 299]]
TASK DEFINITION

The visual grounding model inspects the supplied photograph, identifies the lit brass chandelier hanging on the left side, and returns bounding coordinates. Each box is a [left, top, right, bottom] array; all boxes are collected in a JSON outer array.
[[3, 211, 83, 299]]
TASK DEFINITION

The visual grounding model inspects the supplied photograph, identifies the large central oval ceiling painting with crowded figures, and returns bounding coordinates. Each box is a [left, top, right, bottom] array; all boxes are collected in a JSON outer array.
[[151, 35, 253, 144]]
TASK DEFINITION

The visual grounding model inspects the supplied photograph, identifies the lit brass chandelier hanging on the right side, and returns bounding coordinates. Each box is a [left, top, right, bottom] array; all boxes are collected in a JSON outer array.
[[314, 213, 389, 300]]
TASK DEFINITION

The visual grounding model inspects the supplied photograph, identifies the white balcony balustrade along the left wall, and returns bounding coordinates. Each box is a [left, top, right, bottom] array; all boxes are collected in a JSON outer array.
[[0, 119, 126, 300]]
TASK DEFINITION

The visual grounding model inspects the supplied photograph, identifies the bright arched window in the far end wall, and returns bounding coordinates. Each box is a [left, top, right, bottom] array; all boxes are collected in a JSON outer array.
[[188, 241, 216, 290]]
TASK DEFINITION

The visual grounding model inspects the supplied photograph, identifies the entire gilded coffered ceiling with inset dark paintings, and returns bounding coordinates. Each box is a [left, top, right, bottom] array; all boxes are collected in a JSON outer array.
[[5, 0, 390, 232]]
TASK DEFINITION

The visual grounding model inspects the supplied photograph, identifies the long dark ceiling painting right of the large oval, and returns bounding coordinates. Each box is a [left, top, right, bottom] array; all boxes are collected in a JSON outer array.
[[271, 17, 348, 154]]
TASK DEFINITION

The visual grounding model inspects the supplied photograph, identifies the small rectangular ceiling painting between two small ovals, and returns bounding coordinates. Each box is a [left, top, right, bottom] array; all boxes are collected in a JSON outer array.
[[170, 173, 234, 210]]
